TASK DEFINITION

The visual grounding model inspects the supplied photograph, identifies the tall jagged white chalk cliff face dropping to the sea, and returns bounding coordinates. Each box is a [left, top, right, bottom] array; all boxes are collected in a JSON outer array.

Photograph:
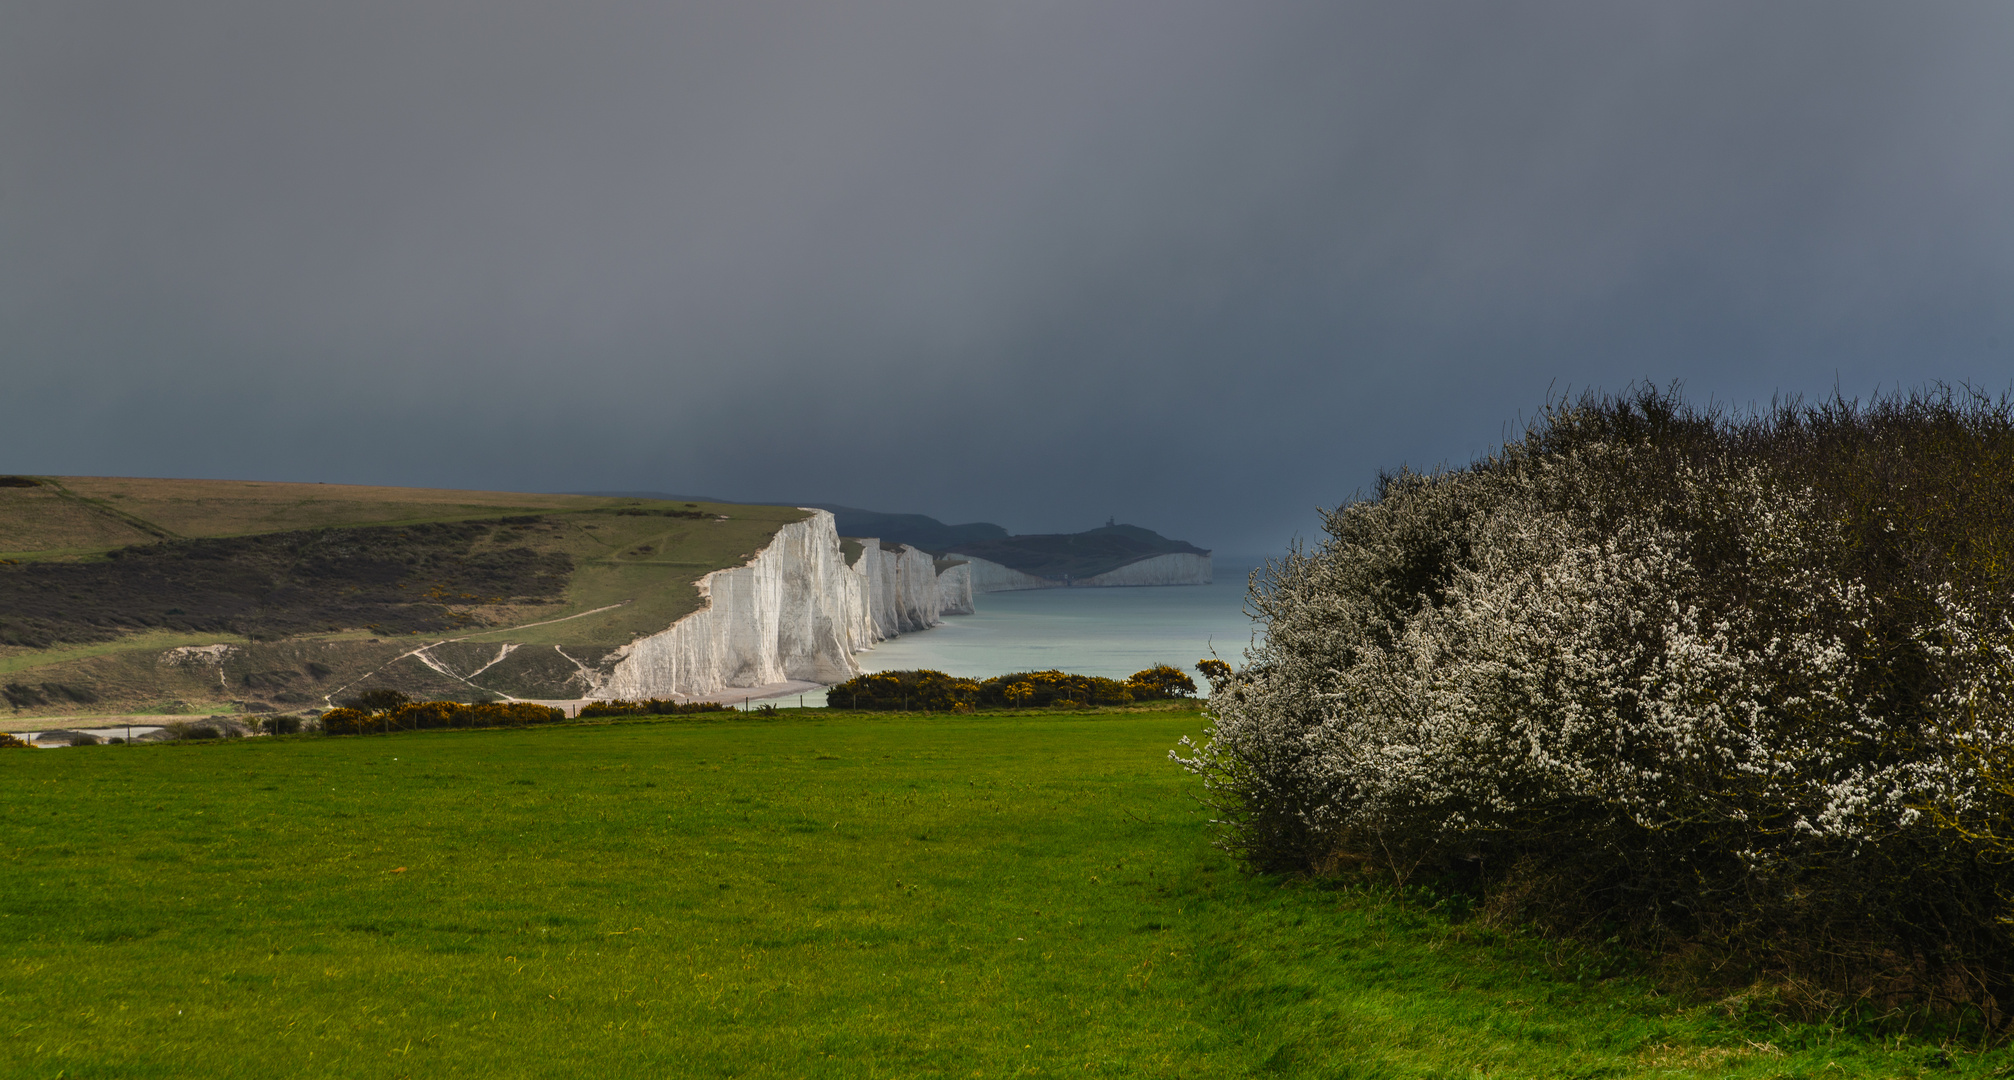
[[586, 510, 975, 701]]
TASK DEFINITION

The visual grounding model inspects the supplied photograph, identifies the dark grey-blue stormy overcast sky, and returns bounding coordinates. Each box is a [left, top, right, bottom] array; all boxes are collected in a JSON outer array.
[[0, 0, 2014, 552]]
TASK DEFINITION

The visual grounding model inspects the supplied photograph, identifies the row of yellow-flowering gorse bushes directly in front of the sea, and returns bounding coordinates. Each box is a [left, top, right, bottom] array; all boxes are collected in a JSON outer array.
[[826, 665, 1196, 713]]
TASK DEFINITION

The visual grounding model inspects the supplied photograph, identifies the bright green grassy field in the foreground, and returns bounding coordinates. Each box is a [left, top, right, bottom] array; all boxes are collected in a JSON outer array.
[[0, 711, 2008, 1078]]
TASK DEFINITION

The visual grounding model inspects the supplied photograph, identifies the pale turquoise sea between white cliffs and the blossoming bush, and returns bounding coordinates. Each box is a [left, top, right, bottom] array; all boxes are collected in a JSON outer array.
[[806, 558, 1259, 705]]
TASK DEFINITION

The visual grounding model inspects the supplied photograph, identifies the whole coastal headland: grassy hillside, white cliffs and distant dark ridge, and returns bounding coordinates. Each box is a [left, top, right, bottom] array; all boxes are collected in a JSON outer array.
[[0, 478, 1210, 727]]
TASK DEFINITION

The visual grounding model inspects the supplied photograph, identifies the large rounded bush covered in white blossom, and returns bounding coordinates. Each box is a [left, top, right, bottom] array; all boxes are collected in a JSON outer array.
[[1178, 391, 2014, 1024]]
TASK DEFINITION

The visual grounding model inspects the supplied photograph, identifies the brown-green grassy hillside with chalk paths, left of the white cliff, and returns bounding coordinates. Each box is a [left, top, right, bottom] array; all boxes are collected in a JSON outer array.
[[0, 478, 804, 717]]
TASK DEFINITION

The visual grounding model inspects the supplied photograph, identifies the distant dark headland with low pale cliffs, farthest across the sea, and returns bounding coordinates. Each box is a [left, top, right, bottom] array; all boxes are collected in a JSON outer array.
[[945, 524, 1210, 592]]
